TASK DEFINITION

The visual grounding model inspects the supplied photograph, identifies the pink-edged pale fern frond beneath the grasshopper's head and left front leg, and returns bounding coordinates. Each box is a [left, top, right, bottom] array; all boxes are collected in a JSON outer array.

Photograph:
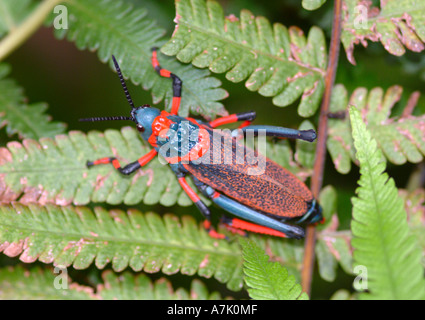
[[0, 127, 312, 206]]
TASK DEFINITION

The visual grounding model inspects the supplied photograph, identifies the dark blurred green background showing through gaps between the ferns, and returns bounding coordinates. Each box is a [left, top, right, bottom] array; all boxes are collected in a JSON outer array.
[[0, 0, 425, 298]]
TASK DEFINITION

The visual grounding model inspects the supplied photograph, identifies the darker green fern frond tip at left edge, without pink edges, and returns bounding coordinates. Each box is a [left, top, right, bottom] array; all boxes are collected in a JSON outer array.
[[0, 64, 66, 139]]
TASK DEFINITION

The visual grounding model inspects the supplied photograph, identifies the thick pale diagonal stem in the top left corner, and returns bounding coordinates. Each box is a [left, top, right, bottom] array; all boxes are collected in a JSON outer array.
[[0, 0, 63, 61]]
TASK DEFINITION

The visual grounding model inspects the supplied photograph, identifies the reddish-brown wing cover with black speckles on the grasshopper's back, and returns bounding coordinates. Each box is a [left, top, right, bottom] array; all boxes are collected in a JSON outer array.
[[184, 129, 313, 218]]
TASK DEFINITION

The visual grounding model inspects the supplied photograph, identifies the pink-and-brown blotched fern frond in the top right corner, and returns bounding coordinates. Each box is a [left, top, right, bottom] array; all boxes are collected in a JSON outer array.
[[341, 0, 425, 64]]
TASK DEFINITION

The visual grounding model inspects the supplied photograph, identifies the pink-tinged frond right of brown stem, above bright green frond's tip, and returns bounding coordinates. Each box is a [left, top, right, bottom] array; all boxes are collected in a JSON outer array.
[[327, 85, 425, 173]]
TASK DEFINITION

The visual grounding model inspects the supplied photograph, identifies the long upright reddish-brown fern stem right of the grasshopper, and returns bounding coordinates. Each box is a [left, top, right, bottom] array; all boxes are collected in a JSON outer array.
[[301, 0, 342, 295]]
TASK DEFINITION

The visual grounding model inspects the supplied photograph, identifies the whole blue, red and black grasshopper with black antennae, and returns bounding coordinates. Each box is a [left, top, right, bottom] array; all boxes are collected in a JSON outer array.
[[81, 48, 322, 239]]
